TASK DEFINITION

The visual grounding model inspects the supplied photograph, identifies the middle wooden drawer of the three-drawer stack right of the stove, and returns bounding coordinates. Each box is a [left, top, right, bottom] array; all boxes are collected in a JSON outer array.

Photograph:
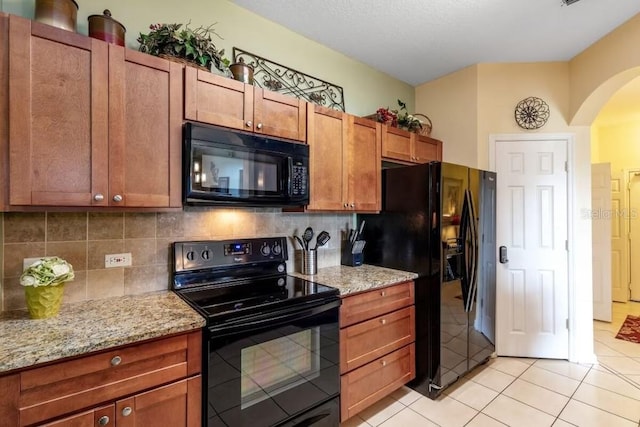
[[340, 306, 416, 373]]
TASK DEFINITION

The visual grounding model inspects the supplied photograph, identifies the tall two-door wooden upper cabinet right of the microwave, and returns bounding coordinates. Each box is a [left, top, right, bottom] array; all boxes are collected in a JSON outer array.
[[306, 104, 381, 212]]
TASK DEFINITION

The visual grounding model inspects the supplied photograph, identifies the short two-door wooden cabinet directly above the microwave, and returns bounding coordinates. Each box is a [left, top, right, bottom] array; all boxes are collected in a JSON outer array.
[[184, 67, 307, 141]]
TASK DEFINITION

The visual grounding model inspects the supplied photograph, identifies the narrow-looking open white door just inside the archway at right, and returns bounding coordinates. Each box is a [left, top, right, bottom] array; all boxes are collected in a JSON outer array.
[[590, 163, 614, 322]]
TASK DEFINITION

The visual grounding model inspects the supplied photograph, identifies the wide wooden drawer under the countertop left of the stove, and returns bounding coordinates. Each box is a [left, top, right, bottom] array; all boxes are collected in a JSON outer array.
[[18, 332, 201, 426]]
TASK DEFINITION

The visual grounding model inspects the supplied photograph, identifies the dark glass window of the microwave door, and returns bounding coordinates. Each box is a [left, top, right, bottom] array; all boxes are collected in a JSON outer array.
[[191, 144, 288, 198]]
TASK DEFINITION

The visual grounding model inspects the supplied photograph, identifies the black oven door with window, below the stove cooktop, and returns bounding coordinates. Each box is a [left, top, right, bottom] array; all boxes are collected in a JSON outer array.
[[208, 299, 340, 427]]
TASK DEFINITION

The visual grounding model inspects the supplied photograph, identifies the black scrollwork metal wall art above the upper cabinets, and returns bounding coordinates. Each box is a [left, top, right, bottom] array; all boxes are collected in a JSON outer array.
[[233, 47, 345, 111]]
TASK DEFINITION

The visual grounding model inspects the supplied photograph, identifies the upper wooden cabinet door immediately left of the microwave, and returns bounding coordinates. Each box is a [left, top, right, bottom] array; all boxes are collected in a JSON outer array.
[[108, 45, 182, 208]]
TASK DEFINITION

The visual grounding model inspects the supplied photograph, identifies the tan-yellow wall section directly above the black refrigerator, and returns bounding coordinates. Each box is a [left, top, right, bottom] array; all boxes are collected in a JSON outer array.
[[416, 65, 478, 166]]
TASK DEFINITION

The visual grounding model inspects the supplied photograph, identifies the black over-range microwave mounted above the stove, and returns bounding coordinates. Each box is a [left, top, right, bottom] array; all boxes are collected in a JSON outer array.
[[182, 123, 309, 207]]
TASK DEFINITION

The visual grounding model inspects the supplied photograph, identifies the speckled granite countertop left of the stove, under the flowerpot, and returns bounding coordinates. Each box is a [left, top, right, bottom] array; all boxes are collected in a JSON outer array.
[[0, 291, 205, 374]]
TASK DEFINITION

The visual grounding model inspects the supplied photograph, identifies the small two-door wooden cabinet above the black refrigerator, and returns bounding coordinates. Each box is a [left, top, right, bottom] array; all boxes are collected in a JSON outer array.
[[382, 125, 442, 163]]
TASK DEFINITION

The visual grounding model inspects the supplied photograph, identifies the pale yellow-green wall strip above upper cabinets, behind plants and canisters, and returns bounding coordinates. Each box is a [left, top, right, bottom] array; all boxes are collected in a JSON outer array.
[[1, 0, 414, 116]]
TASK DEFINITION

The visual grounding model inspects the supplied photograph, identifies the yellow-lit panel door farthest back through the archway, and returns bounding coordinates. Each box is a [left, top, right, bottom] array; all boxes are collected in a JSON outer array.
[[611, 171, 631, 302]]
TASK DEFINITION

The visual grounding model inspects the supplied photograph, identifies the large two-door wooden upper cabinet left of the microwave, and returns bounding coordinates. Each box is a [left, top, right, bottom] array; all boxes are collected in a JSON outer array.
[[9, 16, 182, 208]]
